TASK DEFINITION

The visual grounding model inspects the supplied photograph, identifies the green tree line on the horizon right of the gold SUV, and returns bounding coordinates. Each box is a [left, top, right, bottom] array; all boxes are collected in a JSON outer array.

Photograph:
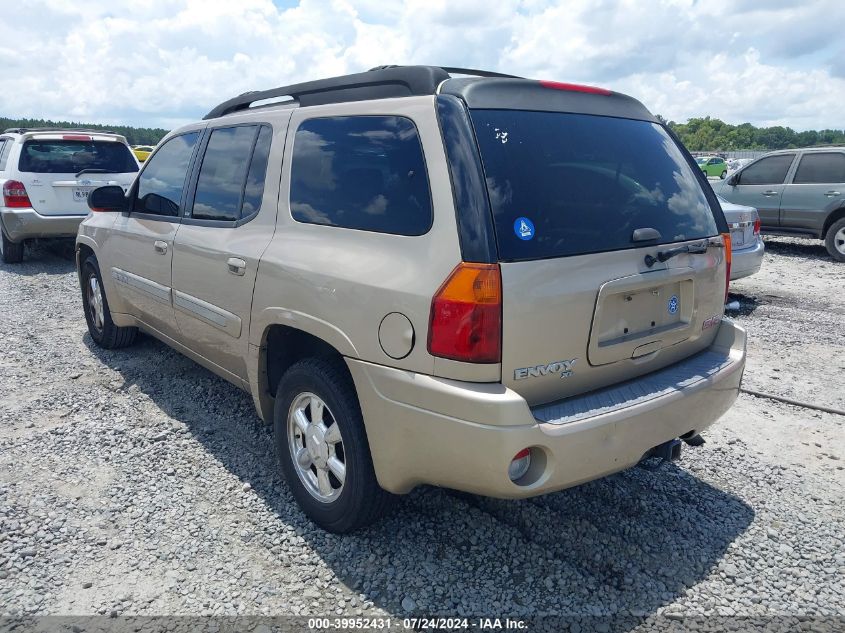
[[658, 115, 845, 151]]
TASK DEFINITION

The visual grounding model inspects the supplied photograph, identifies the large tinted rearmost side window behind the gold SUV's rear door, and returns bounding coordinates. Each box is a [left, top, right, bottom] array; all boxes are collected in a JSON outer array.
[[290, 116, 432, 235]]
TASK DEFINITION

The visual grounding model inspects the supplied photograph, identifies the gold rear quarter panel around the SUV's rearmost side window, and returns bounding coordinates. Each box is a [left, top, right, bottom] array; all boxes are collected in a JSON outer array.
[[250, 97, 474, 380]]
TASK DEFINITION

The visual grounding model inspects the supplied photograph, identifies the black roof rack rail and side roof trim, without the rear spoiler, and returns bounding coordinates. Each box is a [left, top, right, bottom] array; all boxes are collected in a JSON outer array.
[[203, 66, 520, 120]]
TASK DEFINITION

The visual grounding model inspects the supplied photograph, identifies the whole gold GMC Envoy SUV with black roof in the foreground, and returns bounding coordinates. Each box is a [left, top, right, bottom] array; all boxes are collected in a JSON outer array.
[[77, 66, 745, 532]]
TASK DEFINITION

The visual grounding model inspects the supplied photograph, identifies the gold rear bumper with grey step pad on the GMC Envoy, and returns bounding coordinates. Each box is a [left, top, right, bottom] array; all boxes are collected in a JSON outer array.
[[348, 320, 745, 498]]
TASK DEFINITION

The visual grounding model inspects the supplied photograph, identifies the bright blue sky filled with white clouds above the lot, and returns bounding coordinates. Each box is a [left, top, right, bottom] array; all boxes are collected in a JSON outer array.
[[0, 0, 845, 130]]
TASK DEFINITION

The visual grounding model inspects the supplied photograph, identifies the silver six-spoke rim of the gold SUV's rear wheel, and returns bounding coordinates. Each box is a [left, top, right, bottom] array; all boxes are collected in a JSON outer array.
[[288, 392, 346, 503]]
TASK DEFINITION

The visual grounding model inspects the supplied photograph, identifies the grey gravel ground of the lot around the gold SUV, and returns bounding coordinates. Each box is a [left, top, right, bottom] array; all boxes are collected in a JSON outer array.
[[0, 239, 845, 630]]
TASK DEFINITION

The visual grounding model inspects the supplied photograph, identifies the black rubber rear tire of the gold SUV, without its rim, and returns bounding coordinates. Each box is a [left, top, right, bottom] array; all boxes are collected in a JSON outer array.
[[273, 358, 393, 534]]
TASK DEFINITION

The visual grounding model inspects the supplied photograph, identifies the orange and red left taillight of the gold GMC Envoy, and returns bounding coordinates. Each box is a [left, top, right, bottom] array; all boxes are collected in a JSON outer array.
[[428, 262, 502, 363]]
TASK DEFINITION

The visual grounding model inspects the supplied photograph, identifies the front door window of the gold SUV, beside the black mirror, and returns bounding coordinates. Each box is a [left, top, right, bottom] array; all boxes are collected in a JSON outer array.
[[133, 132, 199, 216]]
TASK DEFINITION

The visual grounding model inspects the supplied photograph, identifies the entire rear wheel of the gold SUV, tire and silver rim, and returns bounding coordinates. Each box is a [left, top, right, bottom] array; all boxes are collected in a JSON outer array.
[[273, 358, 392, 534]]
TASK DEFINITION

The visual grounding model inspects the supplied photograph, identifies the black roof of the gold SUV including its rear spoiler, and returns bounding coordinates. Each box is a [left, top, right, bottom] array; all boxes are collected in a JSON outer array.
[[203, 66, 656, 122]]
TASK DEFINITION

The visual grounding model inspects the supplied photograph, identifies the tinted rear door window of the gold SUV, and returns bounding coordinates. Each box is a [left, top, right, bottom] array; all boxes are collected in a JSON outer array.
[[191, 125, 257, 221]]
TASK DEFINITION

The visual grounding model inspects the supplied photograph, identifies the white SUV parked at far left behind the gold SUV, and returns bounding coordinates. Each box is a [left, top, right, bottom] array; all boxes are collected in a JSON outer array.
[[0, 128, 138, 264]]
